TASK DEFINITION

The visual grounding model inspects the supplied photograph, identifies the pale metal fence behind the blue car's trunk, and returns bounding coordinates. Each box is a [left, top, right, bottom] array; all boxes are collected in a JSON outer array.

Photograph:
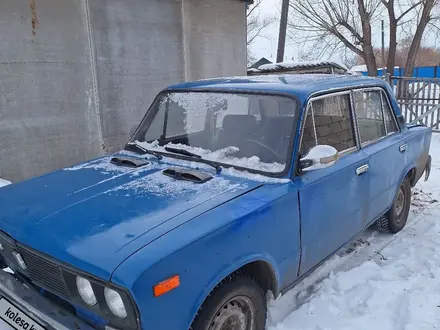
[[387, 77, 440, 130]]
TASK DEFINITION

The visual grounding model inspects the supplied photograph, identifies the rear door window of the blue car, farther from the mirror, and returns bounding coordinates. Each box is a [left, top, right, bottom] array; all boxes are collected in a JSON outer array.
[[354, 91, 386, 144]]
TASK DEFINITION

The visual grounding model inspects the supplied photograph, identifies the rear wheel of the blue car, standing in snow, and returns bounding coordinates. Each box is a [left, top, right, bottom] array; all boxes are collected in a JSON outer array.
[[376, 178, 411, 234]]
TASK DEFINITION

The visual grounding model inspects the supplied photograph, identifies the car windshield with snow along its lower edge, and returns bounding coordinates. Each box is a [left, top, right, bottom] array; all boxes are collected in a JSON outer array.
[[130, 92, 297, 173]]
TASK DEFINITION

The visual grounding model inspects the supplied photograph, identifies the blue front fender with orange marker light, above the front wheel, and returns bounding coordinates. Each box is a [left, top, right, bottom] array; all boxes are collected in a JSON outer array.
[[112, 183, 299, 330]]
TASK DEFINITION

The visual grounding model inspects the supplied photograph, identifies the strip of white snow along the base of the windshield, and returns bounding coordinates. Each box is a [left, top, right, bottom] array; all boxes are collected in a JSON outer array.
[[135, 141, 286, 173]]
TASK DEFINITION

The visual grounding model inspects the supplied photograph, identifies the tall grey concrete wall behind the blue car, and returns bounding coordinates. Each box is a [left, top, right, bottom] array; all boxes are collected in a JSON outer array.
[[0, 0, 246, 181]]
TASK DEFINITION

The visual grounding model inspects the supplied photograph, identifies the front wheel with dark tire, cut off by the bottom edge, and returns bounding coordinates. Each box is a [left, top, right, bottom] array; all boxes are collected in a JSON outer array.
[[190, 272, 267, 330]]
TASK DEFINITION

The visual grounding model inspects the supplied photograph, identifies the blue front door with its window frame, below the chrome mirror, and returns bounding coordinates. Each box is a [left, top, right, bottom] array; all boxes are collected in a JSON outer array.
[[296, 91, 369, 275]]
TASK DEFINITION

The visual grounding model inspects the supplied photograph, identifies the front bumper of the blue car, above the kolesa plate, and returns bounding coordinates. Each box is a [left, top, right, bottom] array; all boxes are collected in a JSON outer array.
[[0, 270, 95, 330]]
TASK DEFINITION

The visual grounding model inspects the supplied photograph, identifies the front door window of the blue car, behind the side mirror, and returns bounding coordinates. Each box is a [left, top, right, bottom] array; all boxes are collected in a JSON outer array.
[[300, 94, 356, 155]]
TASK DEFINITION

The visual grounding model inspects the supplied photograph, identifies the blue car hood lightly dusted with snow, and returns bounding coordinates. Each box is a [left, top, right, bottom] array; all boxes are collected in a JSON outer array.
[[0, 157, 261, 279]]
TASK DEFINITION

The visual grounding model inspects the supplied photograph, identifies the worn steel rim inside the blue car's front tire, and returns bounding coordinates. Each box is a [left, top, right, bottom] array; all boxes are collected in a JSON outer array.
[[209, 296, 256, 330]]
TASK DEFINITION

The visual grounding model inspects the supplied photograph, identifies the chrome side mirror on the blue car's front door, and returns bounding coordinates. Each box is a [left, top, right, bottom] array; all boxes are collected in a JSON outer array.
[[300, 145, 339, 172]]
